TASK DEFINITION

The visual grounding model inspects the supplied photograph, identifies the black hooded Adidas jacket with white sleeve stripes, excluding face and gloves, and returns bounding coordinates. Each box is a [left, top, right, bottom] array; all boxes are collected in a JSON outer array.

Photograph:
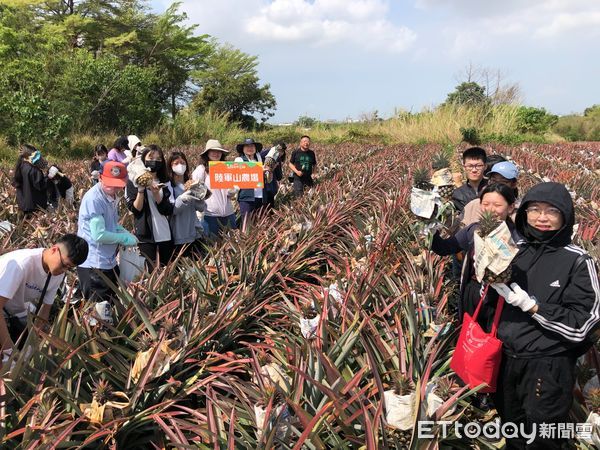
[[498, 183, 600, 358]]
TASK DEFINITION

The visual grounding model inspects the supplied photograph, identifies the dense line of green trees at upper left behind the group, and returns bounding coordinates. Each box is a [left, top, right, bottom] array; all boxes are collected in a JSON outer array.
[[0, 0, 276, 145]]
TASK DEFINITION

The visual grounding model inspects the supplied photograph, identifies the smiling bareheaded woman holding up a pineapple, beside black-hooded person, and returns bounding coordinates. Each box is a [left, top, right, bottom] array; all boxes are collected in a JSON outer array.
[[431, 184, 520, 331]]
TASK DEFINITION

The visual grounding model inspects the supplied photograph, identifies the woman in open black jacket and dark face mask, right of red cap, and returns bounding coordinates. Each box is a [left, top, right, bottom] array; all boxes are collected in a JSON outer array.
[[125, 145, 173, 269]]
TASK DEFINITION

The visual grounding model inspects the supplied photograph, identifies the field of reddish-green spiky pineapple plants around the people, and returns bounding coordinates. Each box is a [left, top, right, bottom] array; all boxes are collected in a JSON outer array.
[[0, 143, 600, 450]]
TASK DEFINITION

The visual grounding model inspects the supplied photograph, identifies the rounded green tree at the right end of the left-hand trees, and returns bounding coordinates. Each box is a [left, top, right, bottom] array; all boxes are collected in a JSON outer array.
[[193, 45, 277, 128]]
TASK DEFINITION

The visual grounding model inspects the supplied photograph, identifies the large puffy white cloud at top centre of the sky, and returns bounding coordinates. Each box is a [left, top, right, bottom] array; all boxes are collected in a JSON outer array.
[[245, 0, 416, 52]]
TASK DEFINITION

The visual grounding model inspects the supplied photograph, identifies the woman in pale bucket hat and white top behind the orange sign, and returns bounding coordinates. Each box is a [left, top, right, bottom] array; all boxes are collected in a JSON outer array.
[[192, 139, 238, 239]]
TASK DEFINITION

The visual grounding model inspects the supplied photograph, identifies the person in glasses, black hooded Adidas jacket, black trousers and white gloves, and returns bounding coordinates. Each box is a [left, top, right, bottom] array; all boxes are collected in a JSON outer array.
[[492, 183, 600, 450]]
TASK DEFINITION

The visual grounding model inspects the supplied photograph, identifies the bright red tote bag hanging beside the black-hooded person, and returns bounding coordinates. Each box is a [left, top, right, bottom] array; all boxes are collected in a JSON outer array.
[[450, 286, 504, 393]]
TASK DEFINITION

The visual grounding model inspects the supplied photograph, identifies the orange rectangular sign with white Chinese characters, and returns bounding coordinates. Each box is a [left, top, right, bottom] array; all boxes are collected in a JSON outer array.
[[208, 161, 265, 189]]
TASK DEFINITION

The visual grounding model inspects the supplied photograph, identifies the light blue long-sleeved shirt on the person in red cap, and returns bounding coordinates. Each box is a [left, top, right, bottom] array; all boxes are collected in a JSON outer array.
[[77, 183, 119, 270]]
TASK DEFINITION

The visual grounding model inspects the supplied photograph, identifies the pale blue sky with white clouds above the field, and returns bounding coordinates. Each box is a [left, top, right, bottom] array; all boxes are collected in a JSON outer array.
[[151, 0, 600, 122]]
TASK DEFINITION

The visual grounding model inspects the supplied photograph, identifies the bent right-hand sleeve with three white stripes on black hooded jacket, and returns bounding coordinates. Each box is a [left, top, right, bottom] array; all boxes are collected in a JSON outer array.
[[533, 253, 600, 342]]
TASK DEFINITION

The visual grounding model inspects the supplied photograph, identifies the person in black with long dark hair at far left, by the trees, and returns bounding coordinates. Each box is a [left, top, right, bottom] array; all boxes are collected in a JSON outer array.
[[13, 144, 48, 215]]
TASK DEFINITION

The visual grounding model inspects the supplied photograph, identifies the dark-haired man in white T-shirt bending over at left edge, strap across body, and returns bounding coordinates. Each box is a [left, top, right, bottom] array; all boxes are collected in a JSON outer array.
[[0, 234, 88, 361]]
